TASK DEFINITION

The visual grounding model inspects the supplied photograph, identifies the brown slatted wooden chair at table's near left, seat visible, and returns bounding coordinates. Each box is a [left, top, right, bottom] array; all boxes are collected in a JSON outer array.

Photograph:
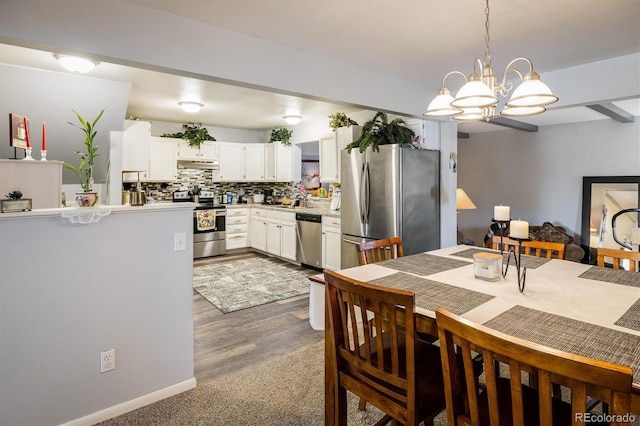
[[324, 270, 444, 425]]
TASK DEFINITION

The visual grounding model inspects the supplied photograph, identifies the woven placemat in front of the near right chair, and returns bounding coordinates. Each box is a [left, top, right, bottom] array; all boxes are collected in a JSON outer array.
[[484, 306, 640, 383]]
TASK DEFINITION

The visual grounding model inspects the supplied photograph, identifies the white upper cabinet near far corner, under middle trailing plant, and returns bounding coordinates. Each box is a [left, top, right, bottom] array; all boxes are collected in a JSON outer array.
[[265, 142, 302, 182]]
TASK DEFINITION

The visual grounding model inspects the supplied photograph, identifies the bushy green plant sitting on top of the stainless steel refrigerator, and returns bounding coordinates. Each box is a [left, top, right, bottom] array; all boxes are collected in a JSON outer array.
[[347, 111, 415, 153]]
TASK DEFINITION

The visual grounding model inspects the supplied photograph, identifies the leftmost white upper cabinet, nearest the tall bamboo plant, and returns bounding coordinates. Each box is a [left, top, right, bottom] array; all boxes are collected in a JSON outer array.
[[122, 120, 151, 172]]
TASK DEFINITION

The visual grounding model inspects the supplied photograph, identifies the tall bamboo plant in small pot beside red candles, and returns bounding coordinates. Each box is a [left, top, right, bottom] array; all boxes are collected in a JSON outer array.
[[64, 109, 104, 207]]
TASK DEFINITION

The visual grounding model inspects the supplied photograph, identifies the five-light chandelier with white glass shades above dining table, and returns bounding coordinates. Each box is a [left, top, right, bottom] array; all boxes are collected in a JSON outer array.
[[424, 0, 558, 121]]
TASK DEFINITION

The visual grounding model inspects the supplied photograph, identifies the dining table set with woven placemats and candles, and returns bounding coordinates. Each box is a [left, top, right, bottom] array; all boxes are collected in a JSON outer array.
[[324, 245, 640, 425]]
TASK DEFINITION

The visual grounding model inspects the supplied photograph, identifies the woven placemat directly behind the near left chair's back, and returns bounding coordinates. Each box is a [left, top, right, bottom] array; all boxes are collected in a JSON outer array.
[[371, 272, 494, 315]]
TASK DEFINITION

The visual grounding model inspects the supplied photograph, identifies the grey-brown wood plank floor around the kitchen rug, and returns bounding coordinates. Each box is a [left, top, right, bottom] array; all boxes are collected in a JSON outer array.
[[193, 252, 324, 384]]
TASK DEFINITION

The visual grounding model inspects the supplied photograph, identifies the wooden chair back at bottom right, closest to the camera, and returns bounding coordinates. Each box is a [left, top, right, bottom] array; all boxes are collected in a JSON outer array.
[[436, 308, 633, 425]]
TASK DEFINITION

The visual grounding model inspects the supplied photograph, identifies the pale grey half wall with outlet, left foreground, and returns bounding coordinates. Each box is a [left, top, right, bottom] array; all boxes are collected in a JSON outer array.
[[0, 204, 195, 425]]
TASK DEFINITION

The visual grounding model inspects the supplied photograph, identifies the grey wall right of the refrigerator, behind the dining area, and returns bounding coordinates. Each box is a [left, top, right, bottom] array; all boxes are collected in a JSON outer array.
[[458, 117, 640, 244]]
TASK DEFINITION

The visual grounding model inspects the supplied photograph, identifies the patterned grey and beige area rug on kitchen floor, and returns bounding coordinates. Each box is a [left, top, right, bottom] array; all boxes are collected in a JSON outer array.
[[193, 258, 309, 314]]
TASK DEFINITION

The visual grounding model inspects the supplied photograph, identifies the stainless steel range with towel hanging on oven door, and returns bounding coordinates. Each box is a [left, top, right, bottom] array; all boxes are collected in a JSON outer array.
[[173, 191, 227, 259]]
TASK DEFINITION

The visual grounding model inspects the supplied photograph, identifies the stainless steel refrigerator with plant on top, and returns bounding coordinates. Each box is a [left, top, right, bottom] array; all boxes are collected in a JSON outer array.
[[340, 145, 440, 269]]
